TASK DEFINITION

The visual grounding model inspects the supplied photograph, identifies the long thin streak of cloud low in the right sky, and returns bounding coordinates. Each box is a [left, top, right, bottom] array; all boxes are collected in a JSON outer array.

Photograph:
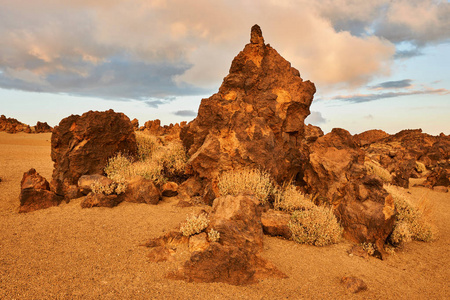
[[331, 88, 450, 103]]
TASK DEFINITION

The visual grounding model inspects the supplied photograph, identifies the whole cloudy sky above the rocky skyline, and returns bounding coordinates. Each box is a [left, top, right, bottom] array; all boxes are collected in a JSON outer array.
[[0, 0, 450, 135]]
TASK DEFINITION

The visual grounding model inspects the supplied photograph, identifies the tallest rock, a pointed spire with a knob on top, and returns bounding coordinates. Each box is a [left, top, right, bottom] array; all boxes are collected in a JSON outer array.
[[180, 25, 316, 182]]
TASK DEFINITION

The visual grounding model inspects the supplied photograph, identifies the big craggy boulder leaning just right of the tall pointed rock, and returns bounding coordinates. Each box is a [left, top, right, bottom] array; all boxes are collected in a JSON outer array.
[[297, 128, 395, 251]]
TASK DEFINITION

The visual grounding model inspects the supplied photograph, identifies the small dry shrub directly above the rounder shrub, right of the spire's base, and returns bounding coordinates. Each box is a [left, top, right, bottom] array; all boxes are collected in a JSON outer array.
[[274, 184, 315, 212]]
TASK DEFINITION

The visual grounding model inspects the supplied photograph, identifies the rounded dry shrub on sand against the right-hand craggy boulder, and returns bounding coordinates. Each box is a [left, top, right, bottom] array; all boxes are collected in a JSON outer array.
[[288, 206, 342, 246]]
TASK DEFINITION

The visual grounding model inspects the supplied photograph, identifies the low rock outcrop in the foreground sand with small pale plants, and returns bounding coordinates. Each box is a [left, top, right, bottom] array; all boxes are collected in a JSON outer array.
[[147, 194, 286, 285]]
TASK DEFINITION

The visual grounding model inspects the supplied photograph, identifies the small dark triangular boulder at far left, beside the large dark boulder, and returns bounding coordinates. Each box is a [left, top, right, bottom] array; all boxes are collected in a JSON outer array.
[[19, 169, 62, 213]]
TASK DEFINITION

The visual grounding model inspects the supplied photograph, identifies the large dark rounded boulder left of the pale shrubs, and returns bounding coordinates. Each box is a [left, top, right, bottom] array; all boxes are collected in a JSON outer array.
[[51, 110, 137, 196]]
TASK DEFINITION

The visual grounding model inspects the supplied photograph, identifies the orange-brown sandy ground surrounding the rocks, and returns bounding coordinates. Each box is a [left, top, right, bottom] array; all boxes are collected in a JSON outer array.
[[0, 132, 450, 299]]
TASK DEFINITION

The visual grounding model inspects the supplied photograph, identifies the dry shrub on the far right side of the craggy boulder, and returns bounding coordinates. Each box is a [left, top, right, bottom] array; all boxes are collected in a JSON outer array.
[[384, 185, 436, 245]]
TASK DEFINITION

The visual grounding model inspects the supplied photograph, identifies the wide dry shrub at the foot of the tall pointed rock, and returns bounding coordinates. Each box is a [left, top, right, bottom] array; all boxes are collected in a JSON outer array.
[[217, 168, 274, 203]]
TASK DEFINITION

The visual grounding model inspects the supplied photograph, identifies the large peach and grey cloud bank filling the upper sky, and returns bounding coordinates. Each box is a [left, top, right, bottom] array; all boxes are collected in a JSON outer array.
[[0, 0, 450, 105]]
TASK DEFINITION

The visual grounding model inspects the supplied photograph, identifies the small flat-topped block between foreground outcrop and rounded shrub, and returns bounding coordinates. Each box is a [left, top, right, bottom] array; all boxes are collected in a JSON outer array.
[[261, 209, 292, 240]]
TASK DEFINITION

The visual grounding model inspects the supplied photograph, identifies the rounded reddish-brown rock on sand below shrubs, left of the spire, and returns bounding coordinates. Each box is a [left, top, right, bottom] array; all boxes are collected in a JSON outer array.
[[120, 176, 161, 205]]
